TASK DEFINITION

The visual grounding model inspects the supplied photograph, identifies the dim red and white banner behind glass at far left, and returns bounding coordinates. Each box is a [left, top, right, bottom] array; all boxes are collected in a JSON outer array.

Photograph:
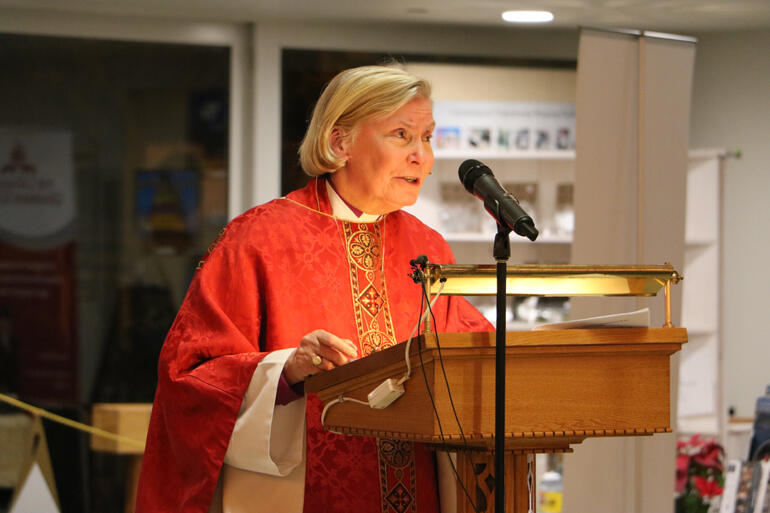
[[0, 127, 78, 404]]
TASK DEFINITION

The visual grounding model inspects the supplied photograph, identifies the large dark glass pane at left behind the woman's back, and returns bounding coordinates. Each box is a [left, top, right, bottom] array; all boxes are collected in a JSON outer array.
[[0, 30, 232, 512]]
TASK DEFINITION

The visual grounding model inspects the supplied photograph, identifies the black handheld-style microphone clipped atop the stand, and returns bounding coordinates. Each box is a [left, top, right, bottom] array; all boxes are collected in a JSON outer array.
[[458, 159, 539, 240]]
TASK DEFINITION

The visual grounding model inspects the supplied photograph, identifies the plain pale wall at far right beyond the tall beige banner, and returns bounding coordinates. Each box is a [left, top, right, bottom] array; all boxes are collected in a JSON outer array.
[[685, 29, 770, 417]]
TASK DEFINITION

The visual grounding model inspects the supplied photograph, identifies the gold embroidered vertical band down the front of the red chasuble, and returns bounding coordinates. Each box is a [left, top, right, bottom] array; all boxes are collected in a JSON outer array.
[[342, 221, 417, 513]]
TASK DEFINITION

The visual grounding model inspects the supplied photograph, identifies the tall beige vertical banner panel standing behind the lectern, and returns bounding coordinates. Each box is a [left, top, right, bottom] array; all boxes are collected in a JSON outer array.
[[564, 30, 695, 513]]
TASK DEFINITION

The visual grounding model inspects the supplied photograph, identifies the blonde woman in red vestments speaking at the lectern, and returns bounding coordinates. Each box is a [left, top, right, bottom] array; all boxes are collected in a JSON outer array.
[[137, 66, 490, 513]]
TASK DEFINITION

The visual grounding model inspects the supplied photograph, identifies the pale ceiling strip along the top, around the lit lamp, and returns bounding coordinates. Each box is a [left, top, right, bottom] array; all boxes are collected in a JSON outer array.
[[0, 0, 770, 33]]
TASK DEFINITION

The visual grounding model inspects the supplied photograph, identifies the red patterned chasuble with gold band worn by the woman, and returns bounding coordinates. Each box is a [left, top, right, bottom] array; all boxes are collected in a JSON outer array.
[[136, 179, 491, 513]]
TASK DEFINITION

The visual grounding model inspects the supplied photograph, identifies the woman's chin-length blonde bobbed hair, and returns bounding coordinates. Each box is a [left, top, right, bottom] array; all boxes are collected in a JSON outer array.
[[299, 66, 431, 176]]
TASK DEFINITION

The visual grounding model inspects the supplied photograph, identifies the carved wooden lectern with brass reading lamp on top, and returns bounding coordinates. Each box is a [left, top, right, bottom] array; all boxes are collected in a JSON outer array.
[[305, 265, 687, 513]]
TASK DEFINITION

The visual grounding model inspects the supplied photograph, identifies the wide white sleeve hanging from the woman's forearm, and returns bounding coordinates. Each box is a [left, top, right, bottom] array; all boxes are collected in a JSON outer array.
[[220, 348, 305, 476]]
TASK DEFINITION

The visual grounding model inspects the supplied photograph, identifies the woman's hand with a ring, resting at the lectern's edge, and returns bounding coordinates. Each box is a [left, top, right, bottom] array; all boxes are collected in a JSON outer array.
[[283, 330, 358, 385]]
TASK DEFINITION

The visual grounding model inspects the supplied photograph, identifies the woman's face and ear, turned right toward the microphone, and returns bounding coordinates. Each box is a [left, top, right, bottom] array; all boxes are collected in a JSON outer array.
[[332, 98, 436, 214]]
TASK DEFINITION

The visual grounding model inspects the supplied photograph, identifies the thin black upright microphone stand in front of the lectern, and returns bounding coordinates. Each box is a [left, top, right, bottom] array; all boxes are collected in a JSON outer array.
[[492, 223, 511, 513]]
